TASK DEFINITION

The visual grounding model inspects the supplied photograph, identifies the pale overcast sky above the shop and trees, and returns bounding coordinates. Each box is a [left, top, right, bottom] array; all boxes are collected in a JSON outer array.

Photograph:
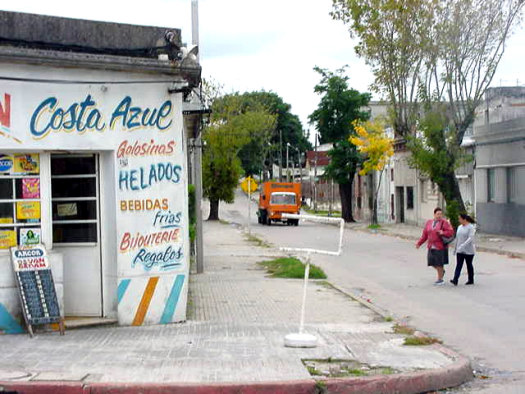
[[0, 0, 525, 137]]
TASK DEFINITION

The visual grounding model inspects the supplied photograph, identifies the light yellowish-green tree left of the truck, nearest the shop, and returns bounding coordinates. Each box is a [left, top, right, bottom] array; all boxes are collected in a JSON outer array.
[[202, 94, 275, 220]]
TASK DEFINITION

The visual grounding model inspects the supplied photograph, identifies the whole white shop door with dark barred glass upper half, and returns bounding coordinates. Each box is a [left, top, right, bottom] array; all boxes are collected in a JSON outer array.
[[51, 154, 103, 317]]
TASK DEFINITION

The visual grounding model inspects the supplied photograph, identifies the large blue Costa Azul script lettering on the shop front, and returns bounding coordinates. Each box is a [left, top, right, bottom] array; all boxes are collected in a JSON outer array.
[[29, 94, 173, 139]]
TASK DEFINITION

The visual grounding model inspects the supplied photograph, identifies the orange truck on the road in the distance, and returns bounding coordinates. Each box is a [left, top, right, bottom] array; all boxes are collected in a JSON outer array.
[[257, 182, 301, 226]]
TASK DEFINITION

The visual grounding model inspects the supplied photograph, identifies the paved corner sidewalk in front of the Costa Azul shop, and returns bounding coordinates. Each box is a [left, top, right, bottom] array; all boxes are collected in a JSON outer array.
[[0, 222, 472, 393]]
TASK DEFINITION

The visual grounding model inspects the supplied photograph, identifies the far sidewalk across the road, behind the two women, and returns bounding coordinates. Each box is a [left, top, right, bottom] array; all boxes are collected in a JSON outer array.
[[347, 223, 525, 259]]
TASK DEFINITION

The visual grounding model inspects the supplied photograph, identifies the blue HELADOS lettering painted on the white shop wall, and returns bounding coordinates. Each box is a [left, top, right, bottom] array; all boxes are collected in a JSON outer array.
[[118, 163, 182, 190]]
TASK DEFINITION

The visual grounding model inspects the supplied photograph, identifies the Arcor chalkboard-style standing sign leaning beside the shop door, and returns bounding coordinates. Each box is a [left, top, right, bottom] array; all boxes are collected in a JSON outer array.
[[11, 244, 64, 337]]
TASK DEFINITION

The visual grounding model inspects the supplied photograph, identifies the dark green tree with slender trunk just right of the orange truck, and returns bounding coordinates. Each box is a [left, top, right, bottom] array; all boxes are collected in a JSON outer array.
[[309, 67, 371, 222]]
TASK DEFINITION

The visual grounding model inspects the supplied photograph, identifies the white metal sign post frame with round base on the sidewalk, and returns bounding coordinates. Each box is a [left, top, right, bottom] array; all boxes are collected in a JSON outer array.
[[280, 213, 345, 347]]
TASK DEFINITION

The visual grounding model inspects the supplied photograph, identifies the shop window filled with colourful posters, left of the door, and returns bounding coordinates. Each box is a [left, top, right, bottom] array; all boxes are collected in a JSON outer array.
[[0, 153, 42, 249]]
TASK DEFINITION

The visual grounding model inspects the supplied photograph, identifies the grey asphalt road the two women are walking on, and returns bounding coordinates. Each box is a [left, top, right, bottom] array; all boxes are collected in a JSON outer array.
[[211, 193, 525, 393]]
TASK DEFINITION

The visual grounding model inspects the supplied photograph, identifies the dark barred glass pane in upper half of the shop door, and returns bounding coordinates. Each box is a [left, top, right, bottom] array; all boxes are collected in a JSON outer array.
[[51, 154, 99, 244]]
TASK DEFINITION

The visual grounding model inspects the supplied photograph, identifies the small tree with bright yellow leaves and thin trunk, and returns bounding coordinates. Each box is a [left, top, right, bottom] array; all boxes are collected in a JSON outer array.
[[349, 119, 394, 225]]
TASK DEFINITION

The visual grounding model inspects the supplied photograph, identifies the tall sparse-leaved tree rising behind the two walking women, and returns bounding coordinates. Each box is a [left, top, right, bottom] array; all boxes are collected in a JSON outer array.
[[332, 0, 524, 225]]
